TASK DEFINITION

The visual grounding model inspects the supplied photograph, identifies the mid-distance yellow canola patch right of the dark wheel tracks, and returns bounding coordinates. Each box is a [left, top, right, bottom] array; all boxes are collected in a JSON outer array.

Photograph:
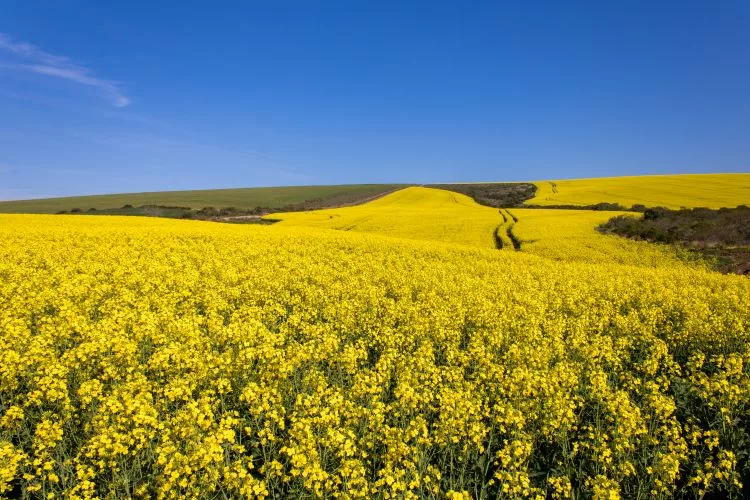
[[508, 208, 705, 267]]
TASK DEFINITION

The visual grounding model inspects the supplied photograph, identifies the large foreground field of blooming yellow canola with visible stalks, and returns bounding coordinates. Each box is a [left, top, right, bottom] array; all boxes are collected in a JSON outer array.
[[0, 216, 750, 498]]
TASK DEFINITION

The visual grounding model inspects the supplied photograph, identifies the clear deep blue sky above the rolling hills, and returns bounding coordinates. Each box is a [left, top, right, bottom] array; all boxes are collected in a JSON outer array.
[[0, 0, 750, 199]]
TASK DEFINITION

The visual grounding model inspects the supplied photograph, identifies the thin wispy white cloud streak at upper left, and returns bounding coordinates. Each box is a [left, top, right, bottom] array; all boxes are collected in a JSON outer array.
[[0, 33, 131, 108]]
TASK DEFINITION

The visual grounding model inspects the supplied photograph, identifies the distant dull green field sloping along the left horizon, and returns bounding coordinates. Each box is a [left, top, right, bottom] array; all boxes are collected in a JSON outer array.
[[0, 184, 404, 213]]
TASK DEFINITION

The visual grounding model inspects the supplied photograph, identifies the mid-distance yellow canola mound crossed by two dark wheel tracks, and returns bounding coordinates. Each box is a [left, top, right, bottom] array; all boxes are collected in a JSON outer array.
[[268, 187, 704, 267]]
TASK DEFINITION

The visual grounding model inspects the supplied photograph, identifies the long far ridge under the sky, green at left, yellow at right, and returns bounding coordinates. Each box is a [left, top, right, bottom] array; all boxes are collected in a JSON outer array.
[[0, 173, 750, 217]]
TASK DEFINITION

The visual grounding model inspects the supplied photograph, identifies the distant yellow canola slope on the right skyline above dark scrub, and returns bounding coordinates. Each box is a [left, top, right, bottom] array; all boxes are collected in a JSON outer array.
[[526, 173, 750, 208]]
